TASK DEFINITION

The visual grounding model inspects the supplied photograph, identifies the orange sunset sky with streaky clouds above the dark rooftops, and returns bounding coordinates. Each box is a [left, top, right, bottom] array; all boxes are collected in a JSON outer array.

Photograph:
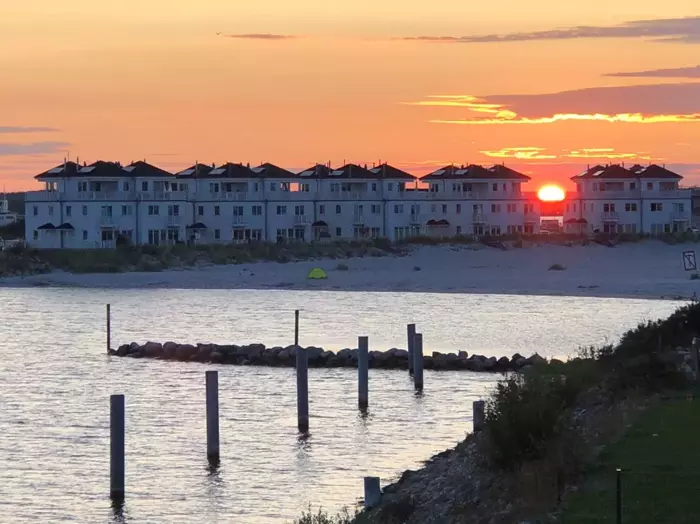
[[0, 0, 700, 191]]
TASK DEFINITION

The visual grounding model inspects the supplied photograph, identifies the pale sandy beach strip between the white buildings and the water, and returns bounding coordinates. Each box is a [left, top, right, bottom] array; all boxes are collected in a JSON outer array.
[[0, 241, 700, 299]]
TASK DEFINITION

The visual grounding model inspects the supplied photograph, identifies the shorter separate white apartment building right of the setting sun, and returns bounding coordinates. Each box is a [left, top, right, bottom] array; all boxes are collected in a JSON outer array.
[[564, 164, 692, 235]]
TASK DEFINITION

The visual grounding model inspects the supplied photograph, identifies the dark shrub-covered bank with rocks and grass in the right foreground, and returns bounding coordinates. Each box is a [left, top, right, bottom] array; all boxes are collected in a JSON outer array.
[[297, 304, 700, 524]]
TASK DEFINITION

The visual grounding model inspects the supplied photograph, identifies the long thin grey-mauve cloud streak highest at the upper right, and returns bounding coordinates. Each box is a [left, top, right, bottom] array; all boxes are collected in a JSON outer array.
[[402, 16, 700, 44]]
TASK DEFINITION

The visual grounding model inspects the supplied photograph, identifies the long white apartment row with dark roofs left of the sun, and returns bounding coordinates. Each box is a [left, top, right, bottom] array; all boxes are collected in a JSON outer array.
[[26, 161, 539, 248]]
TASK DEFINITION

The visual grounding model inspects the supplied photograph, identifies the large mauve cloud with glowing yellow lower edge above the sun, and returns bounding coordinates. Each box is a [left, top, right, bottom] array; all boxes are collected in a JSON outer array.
[[408, 82, 700, 125]]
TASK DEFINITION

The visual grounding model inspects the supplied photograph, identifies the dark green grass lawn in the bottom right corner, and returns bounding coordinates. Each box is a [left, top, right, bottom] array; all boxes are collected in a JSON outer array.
[[557, 399, 700, 524]]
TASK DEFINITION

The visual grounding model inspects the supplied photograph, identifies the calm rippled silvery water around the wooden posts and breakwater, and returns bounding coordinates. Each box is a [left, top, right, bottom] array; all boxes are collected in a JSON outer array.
[[0, 289, 677, 524]]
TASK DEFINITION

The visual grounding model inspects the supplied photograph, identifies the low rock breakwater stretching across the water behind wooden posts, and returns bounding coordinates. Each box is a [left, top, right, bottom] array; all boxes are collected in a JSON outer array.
[[110, 342, 546, 373]]
